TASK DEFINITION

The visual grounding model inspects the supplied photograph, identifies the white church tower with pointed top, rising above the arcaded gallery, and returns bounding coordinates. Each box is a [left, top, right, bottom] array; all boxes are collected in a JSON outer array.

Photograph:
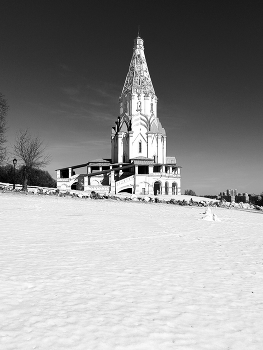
[[111, 36, 166, 164]]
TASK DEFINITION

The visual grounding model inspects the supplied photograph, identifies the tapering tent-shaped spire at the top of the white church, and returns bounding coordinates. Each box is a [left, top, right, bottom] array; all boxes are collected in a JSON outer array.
[[122, 36, 155, 97]]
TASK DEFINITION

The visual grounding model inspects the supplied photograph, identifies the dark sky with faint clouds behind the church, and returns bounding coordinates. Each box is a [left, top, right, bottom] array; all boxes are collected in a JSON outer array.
[[0, 0, 263, 194]]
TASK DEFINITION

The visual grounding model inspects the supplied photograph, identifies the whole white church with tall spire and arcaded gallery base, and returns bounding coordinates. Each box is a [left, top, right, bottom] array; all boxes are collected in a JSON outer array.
[[57, 36, 181, 195]]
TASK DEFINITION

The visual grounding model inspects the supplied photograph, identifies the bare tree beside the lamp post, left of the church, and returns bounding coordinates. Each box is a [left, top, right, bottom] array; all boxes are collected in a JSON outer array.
[[14, 130, 50, 191]]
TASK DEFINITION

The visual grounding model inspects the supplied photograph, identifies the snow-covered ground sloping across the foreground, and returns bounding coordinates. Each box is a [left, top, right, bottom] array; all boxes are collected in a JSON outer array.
[[0, 193, 263, 350]]
